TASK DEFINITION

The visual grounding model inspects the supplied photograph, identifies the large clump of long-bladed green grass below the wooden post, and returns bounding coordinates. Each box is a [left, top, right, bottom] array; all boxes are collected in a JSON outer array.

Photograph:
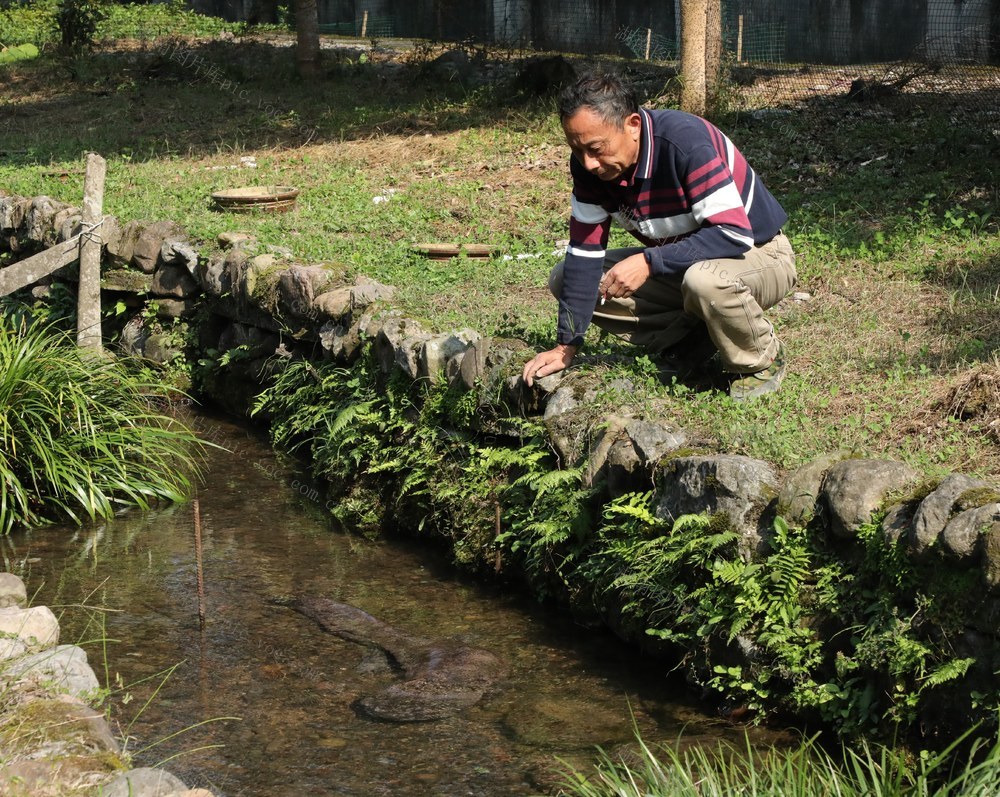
[[0, 317, 199, 532]]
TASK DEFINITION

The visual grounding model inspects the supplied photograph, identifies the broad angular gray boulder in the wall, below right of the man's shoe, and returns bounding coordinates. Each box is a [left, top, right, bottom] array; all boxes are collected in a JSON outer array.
[[656, 454, 778, 557]]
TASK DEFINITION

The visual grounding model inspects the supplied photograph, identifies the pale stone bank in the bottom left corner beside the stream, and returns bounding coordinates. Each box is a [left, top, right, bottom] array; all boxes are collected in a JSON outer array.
[[0, 573, 211, 797]]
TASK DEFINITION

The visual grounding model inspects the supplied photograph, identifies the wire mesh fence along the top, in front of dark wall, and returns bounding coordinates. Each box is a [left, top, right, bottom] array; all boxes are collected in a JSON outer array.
[[312, 0, 1000, 116]]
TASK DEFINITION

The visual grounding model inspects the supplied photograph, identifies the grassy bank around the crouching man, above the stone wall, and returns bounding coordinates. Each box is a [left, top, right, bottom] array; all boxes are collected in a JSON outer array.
[[0, 29, 1000, 486]]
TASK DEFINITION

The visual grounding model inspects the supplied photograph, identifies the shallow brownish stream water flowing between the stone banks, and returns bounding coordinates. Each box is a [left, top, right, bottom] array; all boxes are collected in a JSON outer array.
[[2, 417, 779, 797]]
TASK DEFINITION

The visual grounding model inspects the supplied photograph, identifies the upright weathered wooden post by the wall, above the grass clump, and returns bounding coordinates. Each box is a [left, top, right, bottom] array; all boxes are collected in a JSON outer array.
[[76, 152, 108, 352]]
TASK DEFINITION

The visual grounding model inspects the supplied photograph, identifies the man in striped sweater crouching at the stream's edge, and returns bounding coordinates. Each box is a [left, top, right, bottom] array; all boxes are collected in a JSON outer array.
[[523, 73, 796, 399]]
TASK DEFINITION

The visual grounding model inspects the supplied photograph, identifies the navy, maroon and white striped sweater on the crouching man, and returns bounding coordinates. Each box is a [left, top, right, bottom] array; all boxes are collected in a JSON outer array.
[[557, 109, 788, 346]]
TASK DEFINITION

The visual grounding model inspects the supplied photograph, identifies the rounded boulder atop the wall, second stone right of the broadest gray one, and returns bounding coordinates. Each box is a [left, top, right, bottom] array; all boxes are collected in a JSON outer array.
[[820, 459, 918, 539]]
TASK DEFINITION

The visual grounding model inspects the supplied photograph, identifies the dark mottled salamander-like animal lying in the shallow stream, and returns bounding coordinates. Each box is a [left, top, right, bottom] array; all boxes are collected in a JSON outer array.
[[289, 597, 506, 722]]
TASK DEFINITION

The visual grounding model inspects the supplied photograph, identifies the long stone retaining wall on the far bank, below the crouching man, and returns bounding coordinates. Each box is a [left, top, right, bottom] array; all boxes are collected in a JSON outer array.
[[0, 190, 1000, 736]]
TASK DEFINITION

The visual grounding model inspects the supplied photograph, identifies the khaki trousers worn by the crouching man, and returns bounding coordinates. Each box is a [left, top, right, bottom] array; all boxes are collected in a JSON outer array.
[[549, 233, 797, 373]]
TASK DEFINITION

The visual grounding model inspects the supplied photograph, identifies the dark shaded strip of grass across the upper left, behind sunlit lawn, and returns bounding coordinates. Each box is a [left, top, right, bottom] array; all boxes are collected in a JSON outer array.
[[0, 40, 670, 165]]
